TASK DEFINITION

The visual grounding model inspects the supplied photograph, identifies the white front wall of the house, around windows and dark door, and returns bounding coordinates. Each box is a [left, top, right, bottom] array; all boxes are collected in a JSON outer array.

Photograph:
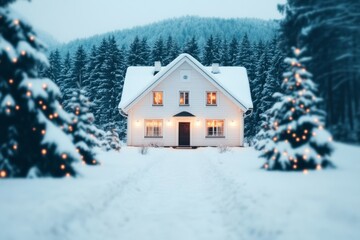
[[128, 62, 244, 146]]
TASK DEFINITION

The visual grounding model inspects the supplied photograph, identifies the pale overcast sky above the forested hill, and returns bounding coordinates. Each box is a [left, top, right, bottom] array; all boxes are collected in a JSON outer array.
[[13, 0, 286, 42]]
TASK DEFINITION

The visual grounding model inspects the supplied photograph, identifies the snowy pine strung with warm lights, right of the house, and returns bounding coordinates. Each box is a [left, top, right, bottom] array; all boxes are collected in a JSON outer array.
[[256, 48, 333, 171]]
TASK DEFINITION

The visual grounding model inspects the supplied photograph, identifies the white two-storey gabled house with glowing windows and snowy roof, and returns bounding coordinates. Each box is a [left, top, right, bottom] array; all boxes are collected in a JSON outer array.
[[119, 54, 253, 146]]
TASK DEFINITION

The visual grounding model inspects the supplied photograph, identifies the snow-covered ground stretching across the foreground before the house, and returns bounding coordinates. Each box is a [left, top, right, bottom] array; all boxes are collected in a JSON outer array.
[[0, 144, 360, 240]]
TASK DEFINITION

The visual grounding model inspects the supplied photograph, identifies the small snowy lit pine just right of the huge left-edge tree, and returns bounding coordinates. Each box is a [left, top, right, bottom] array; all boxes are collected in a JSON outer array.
[[69, 88, 100, 165]]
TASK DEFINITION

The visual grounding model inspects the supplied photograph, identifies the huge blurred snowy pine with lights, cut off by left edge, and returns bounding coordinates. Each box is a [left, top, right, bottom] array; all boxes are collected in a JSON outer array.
[[0, 0, 80, 177]]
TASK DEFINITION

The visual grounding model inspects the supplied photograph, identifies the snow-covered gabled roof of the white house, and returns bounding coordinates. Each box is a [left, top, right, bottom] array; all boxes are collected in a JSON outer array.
[[119, 53, 253, 113]]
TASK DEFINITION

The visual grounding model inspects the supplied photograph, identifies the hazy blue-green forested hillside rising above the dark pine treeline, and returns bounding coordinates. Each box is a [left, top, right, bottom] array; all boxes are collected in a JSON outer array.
[[54, 16, 278, 53]]
